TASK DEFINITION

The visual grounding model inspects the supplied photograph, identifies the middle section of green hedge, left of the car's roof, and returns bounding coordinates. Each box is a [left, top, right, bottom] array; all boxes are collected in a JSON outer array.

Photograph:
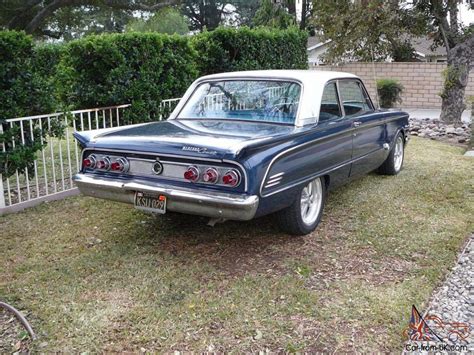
[[58, 33, 197, 123]]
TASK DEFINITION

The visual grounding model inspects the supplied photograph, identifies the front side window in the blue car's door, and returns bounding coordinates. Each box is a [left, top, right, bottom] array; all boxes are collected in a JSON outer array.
[[339, 80, 373, 117]]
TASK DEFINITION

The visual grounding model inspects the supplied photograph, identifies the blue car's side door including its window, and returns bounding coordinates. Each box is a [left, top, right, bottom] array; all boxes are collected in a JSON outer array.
[[338, 79, 385, 176]]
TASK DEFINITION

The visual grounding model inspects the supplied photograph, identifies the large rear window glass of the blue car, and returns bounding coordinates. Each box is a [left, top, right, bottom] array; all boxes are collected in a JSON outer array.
[[178, 80, 301, 123]]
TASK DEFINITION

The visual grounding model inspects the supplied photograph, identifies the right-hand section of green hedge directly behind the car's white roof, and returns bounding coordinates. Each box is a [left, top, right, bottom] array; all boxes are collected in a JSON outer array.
[[192, 27, 308, 75]]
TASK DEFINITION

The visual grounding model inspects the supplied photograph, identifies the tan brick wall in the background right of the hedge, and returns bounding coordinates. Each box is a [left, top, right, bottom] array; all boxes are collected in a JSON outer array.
[[311, 63, 474, 109]]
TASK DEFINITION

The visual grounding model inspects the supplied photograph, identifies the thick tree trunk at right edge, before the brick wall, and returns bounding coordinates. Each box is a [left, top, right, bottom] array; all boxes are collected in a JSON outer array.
[[440, 38, 474, 125]]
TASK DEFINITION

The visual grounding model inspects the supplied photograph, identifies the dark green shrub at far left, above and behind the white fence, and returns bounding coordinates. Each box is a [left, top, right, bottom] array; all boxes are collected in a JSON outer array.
[[0, 31, 60, 177]]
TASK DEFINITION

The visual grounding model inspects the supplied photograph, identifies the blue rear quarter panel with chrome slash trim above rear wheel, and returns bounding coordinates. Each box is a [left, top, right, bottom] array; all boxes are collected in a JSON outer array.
[[239, 120, 352, 214]]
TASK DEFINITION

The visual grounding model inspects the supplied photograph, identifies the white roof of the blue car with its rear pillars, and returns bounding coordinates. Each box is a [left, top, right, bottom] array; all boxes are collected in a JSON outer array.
[[169, 70, 358, 126]]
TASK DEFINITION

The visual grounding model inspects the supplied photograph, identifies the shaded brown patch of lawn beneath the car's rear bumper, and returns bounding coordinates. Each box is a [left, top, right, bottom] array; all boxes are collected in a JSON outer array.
[[140, 214, 305, 274]]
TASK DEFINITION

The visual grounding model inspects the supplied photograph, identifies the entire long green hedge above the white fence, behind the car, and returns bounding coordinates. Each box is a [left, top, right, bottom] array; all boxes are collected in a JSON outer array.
[[0, 27, 307, 122]]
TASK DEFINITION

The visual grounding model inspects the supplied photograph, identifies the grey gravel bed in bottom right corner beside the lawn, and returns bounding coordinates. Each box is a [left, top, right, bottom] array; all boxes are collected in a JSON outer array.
[[405, 235, 474, 354]]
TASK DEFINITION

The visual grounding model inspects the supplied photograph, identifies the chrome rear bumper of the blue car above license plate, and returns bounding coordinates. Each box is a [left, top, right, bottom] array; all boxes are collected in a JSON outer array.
[[73, 174, 258, 220]]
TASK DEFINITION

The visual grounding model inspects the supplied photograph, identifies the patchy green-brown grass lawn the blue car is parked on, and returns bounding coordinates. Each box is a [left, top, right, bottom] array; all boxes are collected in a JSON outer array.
[[0, 138, 474, 352]]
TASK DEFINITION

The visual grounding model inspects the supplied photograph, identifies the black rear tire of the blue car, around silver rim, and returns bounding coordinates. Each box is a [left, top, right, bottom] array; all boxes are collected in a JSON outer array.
[[275, 177, 326, 235]]
